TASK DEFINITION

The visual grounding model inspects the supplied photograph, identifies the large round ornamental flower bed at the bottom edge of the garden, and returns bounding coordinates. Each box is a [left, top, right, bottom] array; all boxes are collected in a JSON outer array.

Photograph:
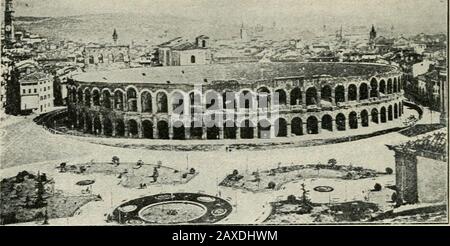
[[108, 193, 232, 224]]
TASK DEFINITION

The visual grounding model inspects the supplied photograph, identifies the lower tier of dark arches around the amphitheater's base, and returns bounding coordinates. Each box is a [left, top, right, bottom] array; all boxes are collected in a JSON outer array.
[[69, 101, 403, 140]]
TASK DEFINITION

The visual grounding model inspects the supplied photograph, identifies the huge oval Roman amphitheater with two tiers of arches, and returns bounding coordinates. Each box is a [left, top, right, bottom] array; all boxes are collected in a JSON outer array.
[[68, 62, 404, 140]]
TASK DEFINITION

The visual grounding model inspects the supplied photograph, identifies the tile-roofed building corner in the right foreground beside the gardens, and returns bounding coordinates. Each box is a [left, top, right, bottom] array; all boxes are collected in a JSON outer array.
[[388, 130, 448, 204]]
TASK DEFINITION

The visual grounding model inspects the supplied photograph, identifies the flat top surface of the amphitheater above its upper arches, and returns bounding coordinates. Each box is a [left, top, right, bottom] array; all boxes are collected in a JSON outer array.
[[73, 62, 398, 84]]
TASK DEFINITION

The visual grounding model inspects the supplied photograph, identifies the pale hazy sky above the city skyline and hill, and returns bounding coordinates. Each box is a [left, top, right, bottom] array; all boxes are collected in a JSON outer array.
[[7, 0, 447, 31]]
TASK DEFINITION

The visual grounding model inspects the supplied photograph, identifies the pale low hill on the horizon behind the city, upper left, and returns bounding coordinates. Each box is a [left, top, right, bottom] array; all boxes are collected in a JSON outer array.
[[15, 14, 243, 43]]
